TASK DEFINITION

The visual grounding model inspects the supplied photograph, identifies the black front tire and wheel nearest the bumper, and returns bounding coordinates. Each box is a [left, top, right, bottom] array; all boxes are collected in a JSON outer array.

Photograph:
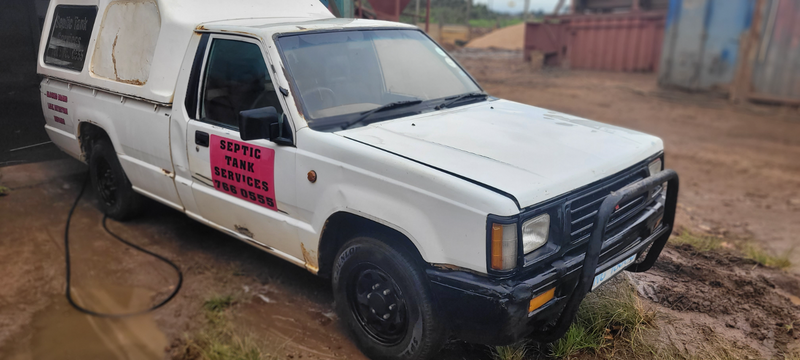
[[332, 237, 446, 360]]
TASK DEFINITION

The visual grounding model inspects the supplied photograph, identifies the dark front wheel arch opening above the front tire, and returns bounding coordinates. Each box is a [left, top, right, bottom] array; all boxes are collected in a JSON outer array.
[[317, 211, 427, 278]]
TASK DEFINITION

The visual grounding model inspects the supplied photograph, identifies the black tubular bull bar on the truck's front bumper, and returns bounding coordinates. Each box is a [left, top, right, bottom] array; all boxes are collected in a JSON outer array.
[[532, 169, 679, 342]]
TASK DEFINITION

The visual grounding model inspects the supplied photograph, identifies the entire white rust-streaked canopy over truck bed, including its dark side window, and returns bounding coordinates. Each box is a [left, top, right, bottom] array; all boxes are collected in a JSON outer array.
[[37, 0, 335, 105]]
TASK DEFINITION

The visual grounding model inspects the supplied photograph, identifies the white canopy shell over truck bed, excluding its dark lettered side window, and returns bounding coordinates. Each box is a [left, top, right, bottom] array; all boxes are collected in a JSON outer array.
[[37, 0, 333, 104]]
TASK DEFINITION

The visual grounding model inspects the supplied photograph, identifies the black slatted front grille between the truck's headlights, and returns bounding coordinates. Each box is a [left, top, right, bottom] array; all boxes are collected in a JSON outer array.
[[566, 168, 651, 245]]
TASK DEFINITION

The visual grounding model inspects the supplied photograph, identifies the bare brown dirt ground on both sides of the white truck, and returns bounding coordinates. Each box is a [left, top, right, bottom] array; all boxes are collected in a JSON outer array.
[[0, 51, 800, 360]]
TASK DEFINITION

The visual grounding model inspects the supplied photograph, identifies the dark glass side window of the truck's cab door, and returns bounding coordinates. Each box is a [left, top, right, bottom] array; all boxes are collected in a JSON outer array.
[[200, 39, 282, 129]]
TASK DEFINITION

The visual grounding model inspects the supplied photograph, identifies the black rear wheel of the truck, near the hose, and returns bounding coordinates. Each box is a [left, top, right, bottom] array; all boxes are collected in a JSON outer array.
[[89, 140, 144, 221]]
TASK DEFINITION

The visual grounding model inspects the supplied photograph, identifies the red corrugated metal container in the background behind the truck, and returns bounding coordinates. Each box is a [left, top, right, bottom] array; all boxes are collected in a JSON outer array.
[[525, 12, 666, 72]]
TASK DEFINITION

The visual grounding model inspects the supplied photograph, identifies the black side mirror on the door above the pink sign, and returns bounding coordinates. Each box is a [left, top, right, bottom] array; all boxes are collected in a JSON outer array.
[[239, 106, 293, 145]]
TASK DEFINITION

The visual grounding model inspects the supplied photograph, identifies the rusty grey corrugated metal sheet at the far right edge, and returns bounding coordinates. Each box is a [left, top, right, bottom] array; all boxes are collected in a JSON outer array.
[[751, 0, 800, 102]]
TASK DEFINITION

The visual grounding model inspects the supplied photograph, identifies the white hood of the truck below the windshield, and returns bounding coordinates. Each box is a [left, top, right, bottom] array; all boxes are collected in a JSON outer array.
[[338, 100, 663, 208]]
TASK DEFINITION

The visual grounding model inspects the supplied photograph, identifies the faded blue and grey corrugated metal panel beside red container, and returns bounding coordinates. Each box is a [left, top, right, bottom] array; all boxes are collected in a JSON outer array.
[[659, 0, 756, 90]]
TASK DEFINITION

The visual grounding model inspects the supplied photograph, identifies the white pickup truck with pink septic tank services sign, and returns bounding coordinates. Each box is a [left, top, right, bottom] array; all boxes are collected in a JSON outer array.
[[38, 0, 678, 359]]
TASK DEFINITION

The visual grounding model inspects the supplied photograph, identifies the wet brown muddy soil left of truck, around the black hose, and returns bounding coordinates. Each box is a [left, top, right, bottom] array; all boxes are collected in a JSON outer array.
[[0, 159, 362, 360]]
